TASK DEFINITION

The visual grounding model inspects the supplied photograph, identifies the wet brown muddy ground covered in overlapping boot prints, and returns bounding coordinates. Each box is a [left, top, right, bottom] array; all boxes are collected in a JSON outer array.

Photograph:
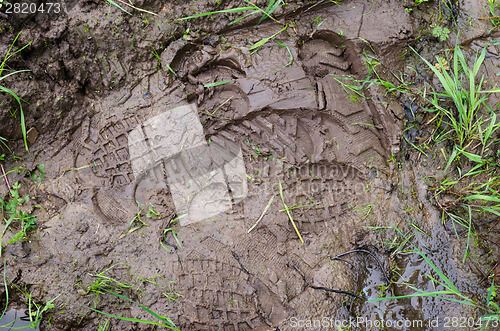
[[0, 0, 500, 330]]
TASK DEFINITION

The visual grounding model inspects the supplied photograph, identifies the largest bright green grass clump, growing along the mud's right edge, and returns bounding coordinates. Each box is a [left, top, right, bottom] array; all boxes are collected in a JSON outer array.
[[412, 44, 500, 248]]
